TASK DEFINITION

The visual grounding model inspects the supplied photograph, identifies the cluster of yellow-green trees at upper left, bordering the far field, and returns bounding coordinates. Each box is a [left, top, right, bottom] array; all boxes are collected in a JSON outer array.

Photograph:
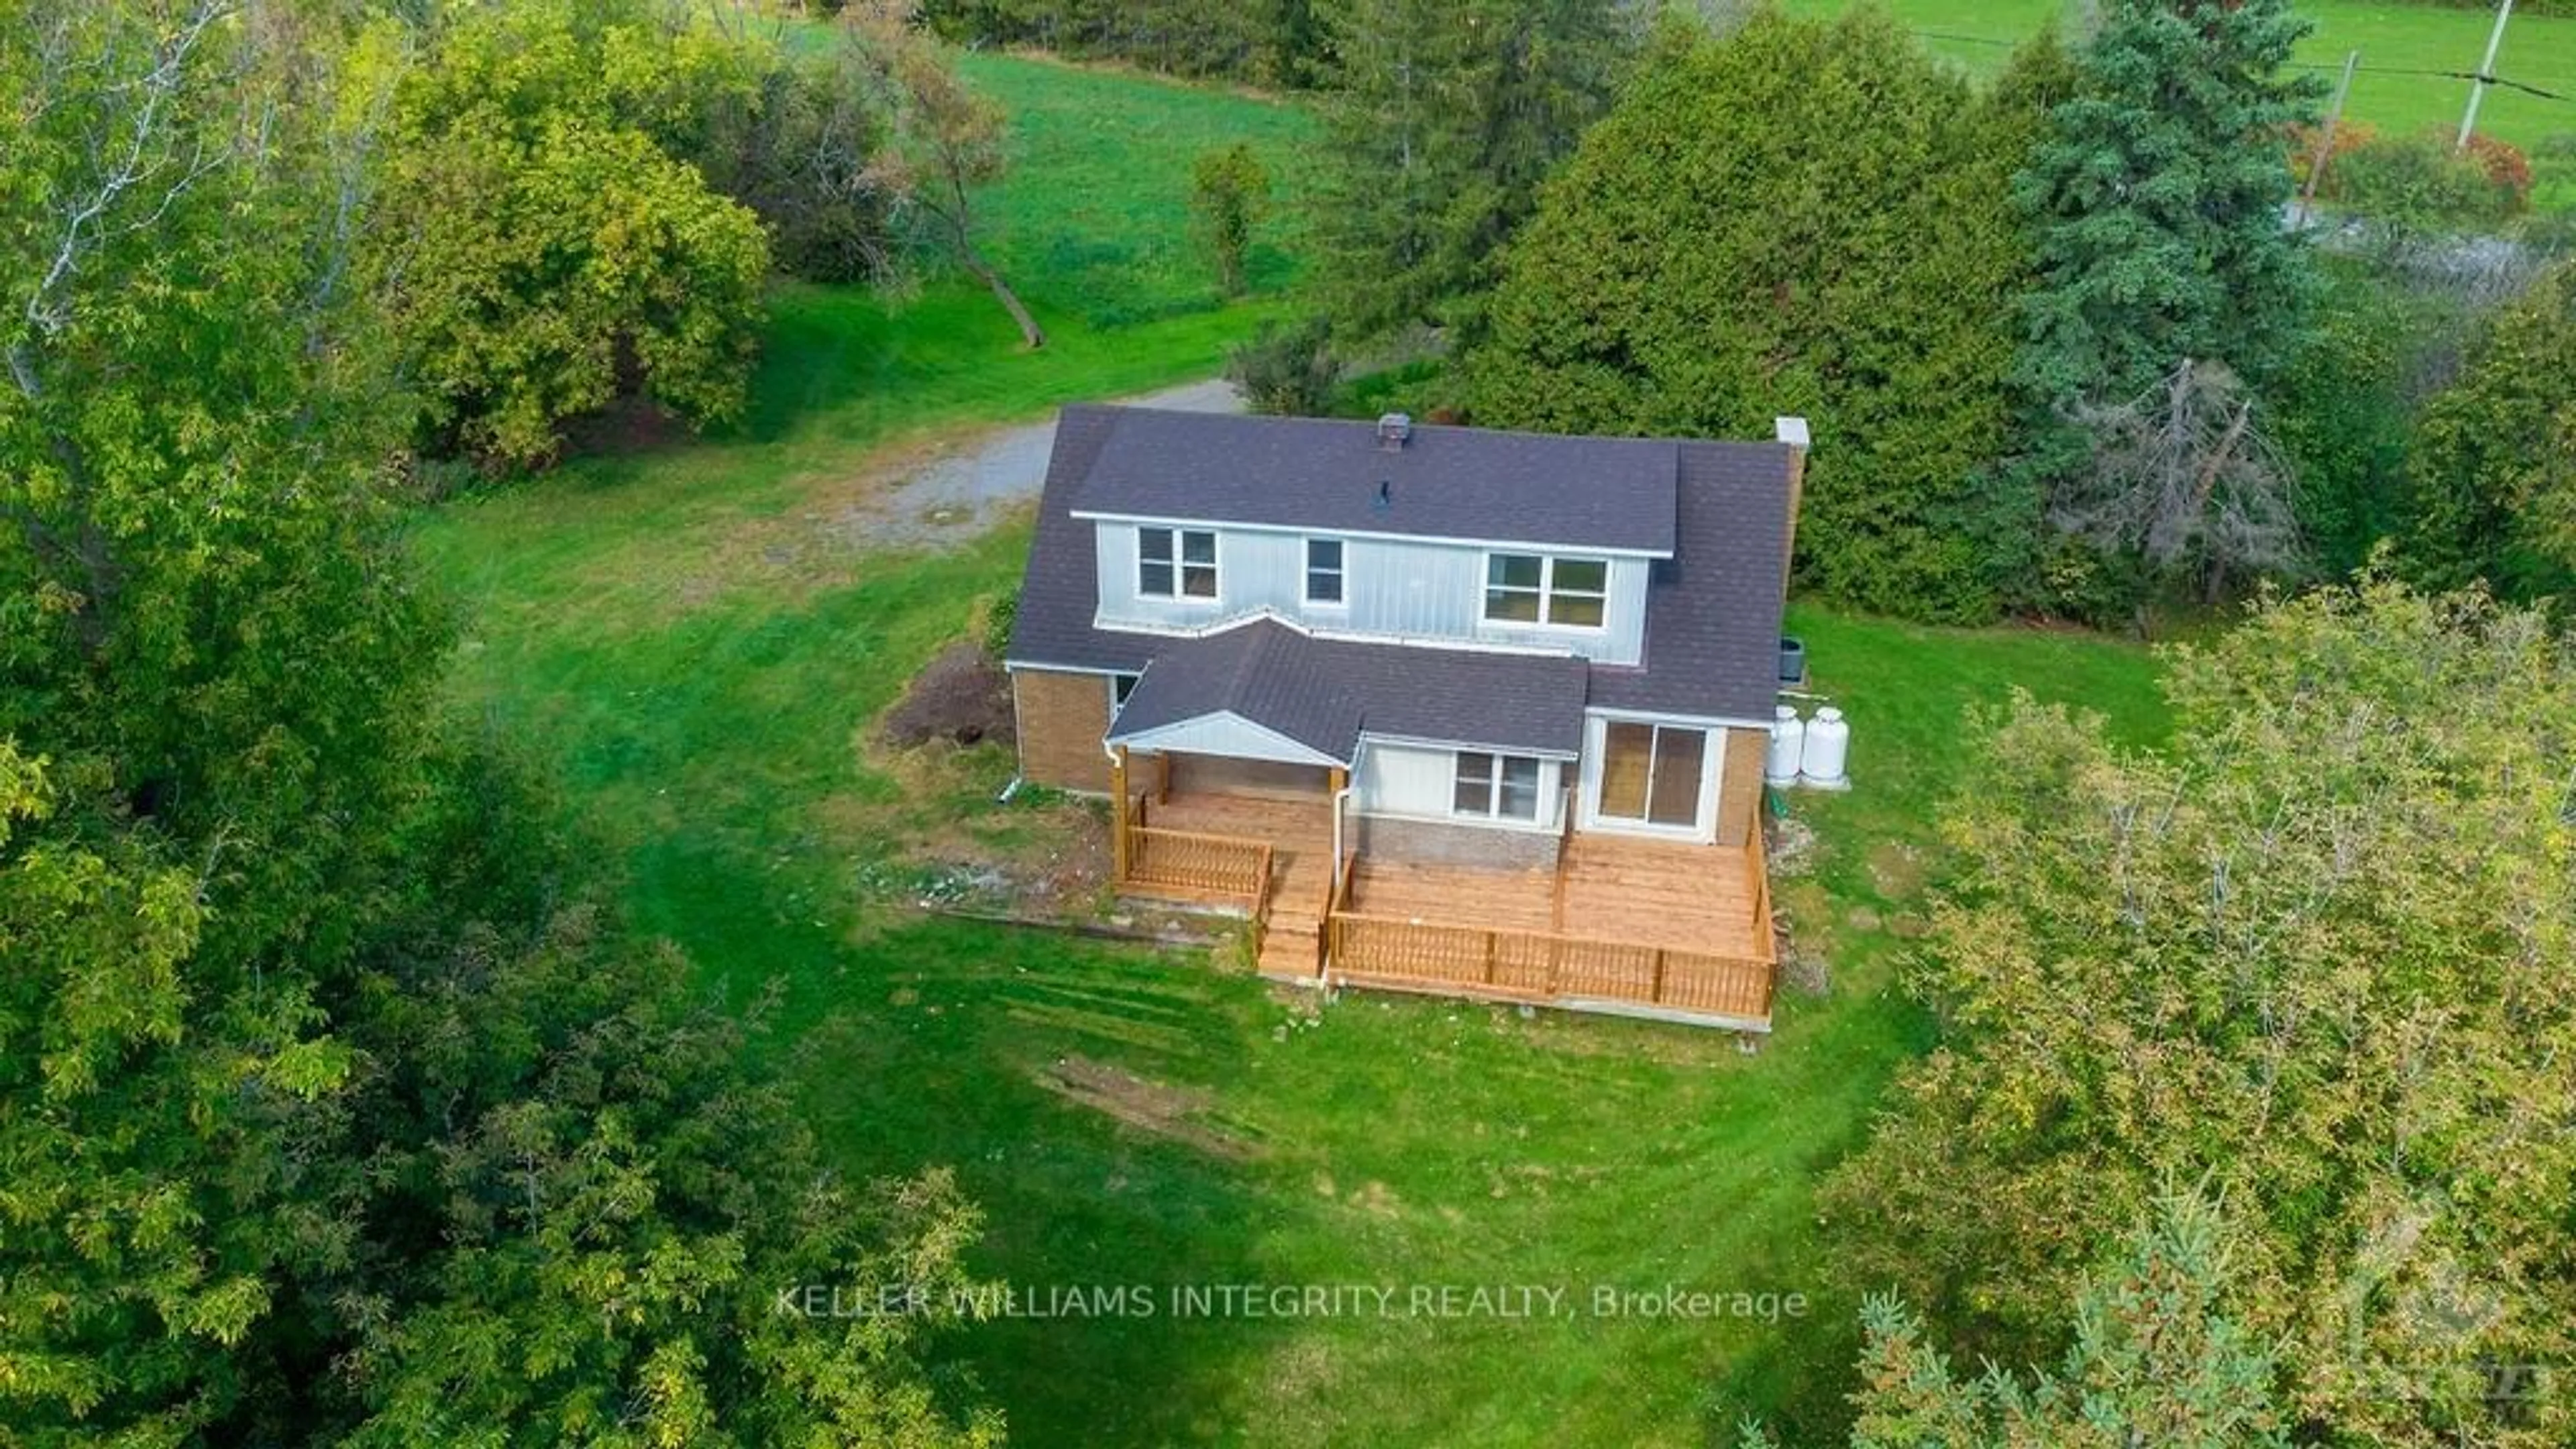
[[88, 0, 1046, 470]]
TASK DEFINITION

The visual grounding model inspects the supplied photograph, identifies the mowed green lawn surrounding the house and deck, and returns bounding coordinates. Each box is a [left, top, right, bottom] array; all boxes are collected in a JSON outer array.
[[415, 45, 2164, 1446]]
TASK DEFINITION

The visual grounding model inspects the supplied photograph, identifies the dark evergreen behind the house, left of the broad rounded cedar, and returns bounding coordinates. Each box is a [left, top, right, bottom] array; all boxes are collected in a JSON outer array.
[[1316, 0, 1641, 337]]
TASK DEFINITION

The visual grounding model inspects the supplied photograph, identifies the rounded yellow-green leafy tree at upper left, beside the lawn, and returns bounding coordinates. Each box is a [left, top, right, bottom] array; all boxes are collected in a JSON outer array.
[[376, 0, 767, 464]]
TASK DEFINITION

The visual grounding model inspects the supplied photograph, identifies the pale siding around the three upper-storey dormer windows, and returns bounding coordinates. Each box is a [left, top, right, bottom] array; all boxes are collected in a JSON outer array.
[[1092, 523, 1654, 665]]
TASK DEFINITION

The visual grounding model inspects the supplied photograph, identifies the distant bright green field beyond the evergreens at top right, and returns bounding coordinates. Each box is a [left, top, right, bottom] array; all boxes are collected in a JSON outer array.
[[1782, 0, 2576, 147]]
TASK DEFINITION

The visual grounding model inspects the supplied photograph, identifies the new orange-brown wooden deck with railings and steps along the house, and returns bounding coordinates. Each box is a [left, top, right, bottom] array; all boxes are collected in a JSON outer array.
[[1120, 778, 1778, 1031]]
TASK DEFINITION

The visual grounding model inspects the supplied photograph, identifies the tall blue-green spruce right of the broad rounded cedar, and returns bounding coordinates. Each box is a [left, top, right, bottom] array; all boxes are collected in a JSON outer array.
[[2015, 0, 2324, 410]]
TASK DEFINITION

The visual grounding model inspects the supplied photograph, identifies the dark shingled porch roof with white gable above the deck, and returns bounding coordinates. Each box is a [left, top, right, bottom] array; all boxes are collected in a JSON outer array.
[[1108, 619, 1587, 765]]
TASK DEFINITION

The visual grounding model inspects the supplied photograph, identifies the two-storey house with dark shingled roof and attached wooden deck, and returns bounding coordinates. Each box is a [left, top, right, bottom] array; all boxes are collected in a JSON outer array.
[[1007, 407, 1806, 1026]]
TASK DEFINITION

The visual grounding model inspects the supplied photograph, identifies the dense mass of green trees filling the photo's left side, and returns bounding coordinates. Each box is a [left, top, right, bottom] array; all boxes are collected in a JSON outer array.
[[0, 0, 1000, 1446]]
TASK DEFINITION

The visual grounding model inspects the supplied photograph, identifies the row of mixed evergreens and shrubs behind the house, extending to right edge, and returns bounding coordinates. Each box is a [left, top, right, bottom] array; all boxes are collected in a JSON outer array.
[[1256, 0, 2576, 627]]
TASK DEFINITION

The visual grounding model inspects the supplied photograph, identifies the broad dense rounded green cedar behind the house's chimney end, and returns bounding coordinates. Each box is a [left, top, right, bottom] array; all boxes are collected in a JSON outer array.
[[1466, 13, 2053, 619]]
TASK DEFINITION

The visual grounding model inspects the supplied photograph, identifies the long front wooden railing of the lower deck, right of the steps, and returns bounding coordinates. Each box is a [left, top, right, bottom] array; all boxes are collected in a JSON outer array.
[[1332, 910, 1772, 1018]]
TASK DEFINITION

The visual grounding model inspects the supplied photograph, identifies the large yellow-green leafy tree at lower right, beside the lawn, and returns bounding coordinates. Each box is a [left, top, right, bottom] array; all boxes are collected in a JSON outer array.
[[1829, 583, 2576, 1449]]
